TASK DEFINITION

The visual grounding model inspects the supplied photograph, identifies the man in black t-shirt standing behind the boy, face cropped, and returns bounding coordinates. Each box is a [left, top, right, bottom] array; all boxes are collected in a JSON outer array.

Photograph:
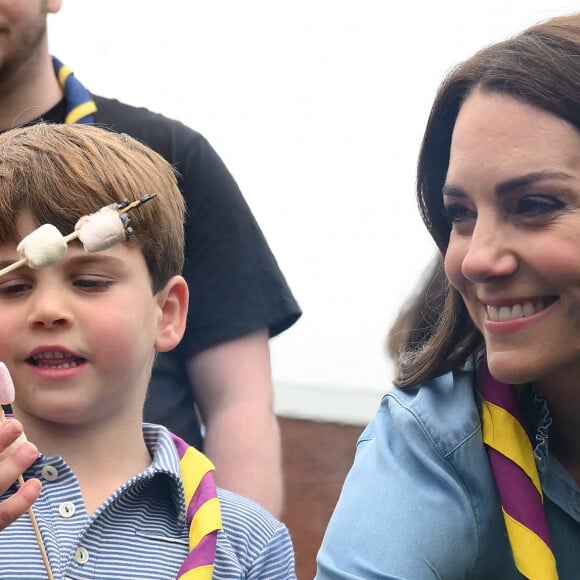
[[0, 0, 300, 516]]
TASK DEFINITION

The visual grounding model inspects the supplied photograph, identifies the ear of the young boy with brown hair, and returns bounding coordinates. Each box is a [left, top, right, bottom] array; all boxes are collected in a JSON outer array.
[[155, 276, 189, 352]]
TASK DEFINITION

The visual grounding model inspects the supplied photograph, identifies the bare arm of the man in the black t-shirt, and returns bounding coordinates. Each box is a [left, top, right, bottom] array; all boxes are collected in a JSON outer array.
[[188, 329, 283, 517]]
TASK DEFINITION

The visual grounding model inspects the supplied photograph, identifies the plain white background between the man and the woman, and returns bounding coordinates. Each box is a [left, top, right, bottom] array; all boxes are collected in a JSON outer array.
[[49, 0, 577, 423]]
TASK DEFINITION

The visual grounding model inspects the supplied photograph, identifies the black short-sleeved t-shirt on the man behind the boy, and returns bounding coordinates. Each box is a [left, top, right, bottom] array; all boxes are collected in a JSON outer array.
[[26, 96, 301, 448]]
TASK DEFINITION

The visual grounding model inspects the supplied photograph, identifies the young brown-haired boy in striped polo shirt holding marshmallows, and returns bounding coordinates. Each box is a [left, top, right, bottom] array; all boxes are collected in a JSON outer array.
[[0, 125, 295, 580]]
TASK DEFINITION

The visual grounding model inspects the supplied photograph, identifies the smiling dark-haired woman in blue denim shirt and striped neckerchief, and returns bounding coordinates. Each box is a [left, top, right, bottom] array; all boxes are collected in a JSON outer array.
[[318, 14, 580, 580]]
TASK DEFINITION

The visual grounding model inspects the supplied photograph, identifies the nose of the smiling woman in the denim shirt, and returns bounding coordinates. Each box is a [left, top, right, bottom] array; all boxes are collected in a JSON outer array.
[[461, 220, 518, 282]]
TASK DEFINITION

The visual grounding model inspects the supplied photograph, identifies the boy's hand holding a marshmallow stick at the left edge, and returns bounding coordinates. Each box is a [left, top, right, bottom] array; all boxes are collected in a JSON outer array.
[[0, 419, 42, 530]]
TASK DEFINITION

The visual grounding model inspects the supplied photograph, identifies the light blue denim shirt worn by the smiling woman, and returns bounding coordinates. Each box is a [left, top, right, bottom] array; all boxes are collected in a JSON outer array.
[[316, 365, 580, 580]]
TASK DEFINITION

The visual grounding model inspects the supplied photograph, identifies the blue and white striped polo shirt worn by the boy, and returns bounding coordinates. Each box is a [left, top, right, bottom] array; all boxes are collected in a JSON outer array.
[[0, 424, 296, 580]]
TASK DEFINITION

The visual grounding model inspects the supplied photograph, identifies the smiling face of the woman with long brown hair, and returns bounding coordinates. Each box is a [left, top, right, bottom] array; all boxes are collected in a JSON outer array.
[[443, 91, 580, 390]]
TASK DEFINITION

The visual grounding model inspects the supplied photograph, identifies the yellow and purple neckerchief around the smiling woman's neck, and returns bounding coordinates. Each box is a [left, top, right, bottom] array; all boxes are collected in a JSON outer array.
[[482, 357, 558, 580]]
